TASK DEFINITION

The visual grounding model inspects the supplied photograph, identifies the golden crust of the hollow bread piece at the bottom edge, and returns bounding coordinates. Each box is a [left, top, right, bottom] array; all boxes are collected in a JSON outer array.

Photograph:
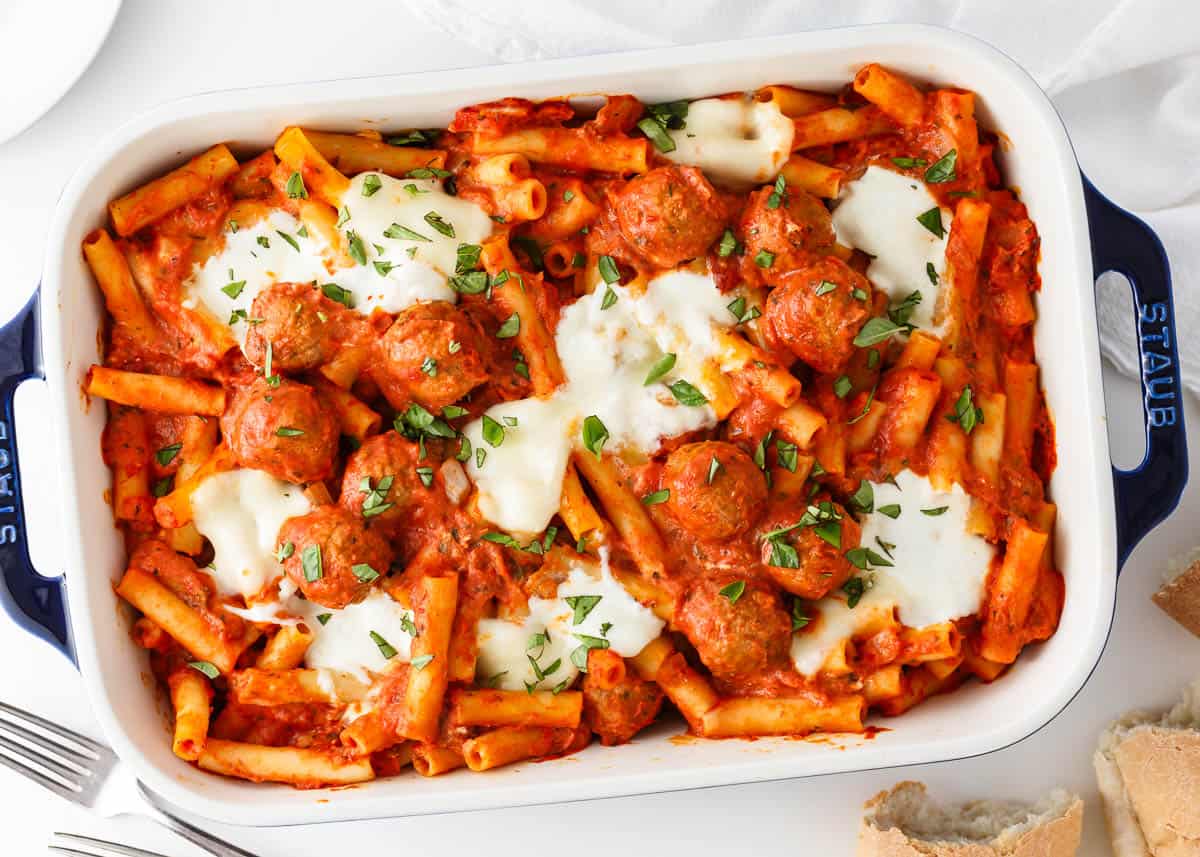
[[858, 784, 1084, 857]]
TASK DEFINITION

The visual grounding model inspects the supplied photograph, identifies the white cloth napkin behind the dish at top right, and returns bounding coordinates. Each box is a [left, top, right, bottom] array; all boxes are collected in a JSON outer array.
[[406, 0, 1200, 392]]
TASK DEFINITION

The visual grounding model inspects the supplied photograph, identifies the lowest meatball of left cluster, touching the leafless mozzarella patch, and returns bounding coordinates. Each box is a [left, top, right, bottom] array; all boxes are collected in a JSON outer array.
[[278, 505, 391, 610]]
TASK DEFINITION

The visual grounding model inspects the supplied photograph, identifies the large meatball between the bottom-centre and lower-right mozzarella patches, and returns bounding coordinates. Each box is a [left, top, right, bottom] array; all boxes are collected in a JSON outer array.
[[674, 577, 792, 679]]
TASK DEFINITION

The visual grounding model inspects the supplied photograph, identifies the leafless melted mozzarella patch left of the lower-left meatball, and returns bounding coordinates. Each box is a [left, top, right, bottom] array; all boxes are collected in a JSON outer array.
[[192, 469, 312, 599]]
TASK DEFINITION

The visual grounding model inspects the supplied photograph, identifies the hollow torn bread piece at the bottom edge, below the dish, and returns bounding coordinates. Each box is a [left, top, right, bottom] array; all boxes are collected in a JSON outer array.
[[858, 783, 1084, 857]]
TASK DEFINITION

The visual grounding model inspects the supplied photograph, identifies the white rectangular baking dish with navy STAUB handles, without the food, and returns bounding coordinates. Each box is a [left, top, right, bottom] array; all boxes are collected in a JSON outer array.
[[0, 25, 1187, 826]]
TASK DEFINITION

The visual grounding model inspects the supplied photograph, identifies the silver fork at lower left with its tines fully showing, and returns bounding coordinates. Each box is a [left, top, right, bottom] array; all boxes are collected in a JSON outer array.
[[0, 702, 258, 857]]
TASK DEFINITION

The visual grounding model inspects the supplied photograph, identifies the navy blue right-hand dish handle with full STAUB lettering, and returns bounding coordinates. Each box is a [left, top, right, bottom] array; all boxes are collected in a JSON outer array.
[[1084, 176, 1188, 570]]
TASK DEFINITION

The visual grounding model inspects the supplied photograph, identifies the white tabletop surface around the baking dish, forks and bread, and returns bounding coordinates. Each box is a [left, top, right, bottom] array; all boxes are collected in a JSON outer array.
[[0, 0, 1200, 857]]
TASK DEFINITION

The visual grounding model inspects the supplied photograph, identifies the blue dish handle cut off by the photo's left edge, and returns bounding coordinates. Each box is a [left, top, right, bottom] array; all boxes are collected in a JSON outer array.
[[0, 289, 76, 661]]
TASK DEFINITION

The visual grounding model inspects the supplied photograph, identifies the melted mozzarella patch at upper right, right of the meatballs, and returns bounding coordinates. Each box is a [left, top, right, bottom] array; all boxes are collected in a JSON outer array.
[[833, 166, 952, 329]]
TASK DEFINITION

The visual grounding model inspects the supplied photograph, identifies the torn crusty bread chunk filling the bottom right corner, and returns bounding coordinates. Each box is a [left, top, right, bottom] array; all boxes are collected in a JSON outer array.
[[1092, 681, 1200, 857]]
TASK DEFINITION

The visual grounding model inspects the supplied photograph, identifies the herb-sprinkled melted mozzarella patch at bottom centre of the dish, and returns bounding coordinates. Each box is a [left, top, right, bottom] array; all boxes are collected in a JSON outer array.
[[475, 552, 665, 690]]
